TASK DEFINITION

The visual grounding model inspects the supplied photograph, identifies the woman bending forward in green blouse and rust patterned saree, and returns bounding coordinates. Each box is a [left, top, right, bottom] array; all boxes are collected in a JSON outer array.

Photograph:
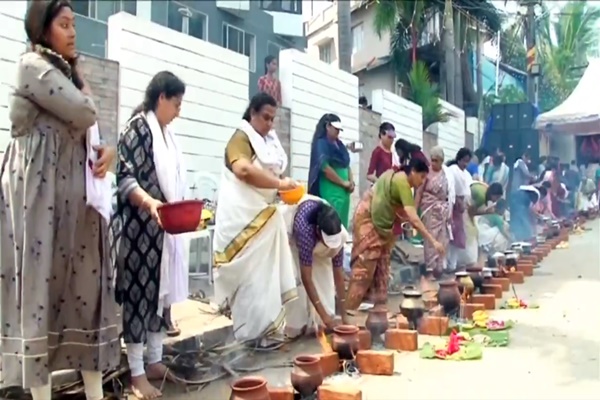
[[345, 159, 445, 310]]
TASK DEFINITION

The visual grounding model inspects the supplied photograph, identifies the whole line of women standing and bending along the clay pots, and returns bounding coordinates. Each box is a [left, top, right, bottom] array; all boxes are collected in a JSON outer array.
[[0, 0, 600, 400]]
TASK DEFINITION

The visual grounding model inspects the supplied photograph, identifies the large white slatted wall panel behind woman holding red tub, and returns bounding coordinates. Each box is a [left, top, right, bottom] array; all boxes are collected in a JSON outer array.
[[108, 13, 249, 187]]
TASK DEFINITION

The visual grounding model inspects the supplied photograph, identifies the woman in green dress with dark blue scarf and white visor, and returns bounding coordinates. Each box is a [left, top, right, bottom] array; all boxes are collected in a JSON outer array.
[[308, 114, 356, 229]]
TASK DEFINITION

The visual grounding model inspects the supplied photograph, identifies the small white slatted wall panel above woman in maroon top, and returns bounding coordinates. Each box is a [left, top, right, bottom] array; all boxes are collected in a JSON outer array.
[[371, 89, 423, 147]]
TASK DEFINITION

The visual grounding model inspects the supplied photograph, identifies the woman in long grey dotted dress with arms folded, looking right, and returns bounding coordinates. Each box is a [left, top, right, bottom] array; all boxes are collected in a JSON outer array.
[[0, 0, 121, 400]]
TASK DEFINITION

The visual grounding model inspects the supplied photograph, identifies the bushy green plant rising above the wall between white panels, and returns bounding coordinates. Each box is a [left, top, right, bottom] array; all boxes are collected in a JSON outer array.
[[408, 61, 451, 130]]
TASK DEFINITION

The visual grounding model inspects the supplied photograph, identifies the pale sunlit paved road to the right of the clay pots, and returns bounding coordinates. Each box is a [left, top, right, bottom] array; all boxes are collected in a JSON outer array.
[[165, 221, 600, 400]]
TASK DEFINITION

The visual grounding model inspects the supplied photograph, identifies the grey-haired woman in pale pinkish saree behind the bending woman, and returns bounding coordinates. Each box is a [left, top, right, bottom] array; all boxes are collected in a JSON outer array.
[[416, 146, 450, 276]]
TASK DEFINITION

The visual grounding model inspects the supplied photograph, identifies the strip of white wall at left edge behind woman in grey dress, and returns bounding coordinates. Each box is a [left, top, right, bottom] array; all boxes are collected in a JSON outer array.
[[0, 1, 27, 162]]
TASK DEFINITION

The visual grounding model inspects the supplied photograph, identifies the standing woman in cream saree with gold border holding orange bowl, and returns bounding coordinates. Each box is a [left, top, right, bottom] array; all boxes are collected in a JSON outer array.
[[213, 93, 297, 346]]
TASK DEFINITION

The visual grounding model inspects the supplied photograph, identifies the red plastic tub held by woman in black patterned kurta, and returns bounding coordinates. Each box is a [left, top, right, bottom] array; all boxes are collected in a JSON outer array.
[[158, 200, 204, 235]]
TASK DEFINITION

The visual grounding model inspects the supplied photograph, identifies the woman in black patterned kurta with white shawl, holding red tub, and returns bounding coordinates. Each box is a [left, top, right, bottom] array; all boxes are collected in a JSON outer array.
[[113, 71, 188, 399]]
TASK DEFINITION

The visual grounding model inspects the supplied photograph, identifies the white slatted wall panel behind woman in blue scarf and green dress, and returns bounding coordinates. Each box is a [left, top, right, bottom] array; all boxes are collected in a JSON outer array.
[[279, 49, 359, 182]]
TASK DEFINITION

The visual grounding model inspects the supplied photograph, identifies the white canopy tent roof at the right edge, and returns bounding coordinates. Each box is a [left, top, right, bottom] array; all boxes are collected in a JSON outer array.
[[535, 59, 600, 136]]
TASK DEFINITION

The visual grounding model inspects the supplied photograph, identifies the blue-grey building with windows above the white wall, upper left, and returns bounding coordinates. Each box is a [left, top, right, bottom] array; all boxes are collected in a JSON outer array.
[[72, 0, 306, 96]]
